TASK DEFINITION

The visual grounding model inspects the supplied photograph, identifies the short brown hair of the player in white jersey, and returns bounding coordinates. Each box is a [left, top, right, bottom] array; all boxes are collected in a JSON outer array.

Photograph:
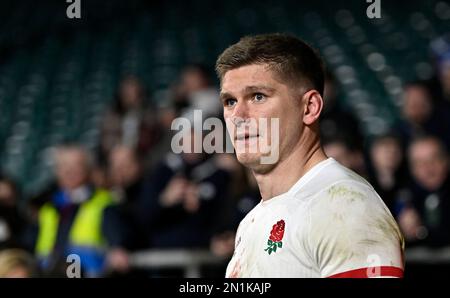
[[216, 33, 324, 95]]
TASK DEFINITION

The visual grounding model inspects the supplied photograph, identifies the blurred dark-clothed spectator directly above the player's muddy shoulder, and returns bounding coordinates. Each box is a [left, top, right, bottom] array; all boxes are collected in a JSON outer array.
[[369, 135, 407, 213]]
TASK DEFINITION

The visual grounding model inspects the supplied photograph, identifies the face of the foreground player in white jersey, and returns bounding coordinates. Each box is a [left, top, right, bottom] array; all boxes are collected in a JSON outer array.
[[221, 64, 303, 173]]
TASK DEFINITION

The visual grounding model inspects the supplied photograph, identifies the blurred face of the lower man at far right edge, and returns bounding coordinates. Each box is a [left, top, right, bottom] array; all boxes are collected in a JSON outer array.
[[410, 140, 448, 191]]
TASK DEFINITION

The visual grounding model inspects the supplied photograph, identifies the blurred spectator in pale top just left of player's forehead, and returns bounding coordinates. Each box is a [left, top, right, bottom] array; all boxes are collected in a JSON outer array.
[[173, 64, 222, 118]]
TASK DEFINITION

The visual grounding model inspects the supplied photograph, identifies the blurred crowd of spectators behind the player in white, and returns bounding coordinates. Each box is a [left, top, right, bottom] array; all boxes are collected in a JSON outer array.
[[0, 37, 450, 277]]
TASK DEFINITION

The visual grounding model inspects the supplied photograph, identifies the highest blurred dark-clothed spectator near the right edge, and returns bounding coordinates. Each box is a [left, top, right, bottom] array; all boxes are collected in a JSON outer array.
[[396, 82, 450, 146]]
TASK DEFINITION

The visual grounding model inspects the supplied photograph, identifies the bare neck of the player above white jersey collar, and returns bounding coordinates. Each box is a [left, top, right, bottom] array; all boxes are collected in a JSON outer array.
[[254, 142, 327, 201]]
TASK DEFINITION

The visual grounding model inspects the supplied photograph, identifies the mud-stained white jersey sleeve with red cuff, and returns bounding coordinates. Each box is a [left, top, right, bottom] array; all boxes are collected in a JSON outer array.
[[307, 181, 404, 278]]
